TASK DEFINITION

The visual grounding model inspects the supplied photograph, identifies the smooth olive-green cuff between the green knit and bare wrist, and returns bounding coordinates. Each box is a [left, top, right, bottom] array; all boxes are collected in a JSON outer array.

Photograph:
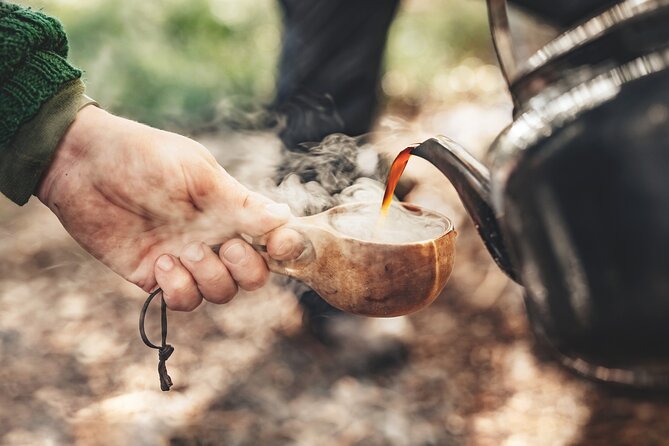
[[0, 79, 97, 205]]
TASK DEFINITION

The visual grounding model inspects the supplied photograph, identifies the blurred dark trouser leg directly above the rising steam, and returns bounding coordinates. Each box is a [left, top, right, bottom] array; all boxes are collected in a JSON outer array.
[[274, 0, 399, 150]]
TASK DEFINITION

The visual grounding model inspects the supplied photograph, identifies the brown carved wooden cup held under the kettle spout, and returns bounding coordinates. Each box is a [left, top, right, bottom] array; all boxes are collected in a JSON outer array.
[[253, 203, 457, 317]]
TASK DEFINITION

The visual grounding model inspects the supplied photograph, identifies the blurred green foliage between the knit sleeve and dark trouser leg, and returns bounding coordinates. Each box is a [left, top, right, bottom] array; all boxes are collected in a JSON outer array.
[[18, 0, 280, 127]]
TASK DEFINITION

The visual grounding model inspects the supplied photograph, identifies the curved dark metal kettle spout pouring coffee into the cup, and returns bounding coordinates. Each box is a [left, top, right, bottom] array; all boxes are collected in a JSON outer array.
[[411, 136, 520, 283]]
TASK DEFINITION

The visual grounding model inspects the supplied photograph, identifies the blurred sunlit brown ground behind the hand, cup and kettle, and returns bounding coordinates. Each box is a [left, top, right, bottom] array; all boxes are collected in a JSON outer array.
[[0, 104, 669, 446]]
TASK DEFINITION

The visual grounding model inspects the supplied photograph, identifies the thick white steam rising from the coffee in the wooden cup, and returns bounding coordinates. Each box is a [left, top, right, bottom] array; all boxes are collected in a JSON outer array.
[[250, 134, 446, 243]]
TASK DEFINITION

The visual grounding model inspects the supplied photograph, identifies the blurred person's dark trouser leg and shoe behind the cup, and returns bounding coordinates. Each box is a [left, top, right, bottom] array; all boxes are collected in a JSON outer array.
[[273, 0, 409, 362]]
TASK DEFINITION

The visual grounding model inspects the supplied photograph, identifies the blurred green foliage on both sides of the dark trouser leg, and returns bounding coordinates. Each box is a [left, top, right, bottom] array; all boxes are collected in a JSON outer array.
[[15, 0, 490, 127]]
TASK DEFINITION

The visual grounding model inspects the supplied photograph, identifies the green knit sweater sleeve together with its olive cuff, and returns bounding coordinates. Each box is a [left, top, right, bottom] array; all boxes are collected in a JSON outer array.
[[0, 1, 92, 204]]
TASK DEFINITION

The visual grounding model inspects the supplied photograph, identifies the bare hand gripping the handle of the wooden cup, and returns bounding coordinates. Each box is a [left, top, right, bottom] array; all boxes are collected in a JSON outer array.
[[37, 106, 301, 311]]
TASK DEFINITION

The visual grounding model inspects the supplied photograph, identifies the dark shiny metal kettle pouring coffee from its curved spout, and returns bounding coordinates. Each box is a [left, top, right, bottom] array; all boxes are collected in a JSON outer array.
[[413, 0, 669, 388]]
